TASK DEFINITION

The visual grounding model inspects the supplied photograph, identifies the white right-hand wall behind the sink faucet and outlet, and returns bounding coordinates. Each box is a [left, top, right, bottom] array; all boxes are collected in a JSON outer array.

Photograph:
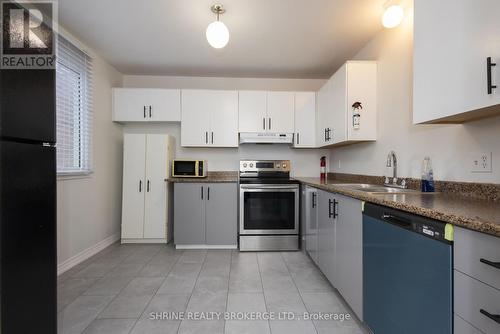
[[330, 5, 500, 183]]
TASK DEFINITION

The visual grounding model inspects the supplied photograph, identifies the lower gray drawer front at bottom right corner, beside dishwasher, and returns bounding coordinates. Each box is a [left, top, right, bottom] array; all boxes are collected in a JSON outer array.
[[454, 270, 500, 334]]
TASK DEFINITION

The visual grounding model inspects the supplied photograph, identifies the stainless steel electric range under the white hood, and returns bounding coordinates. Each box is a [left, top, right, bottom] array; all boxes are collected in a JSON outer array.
[[239, 160, 300, 251]]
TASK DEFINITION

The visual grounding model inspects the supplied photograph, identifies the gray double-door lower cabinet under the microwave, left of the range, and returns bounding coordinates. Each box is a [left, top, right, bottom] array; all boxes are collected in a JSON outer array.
[[174, 183, 237, 247]]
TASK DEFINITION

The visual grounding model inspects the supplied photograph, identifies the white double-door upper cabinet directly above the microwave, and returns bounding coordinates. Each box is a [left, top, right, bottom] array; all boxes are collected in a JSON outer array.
[[181, 89, 238, 147]]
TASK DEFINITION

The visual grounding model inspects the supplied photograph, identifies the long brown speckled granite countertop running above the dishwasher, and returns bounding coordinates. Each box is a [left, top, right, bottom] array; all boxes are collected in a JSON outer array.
[[295, 177, 500, 237]]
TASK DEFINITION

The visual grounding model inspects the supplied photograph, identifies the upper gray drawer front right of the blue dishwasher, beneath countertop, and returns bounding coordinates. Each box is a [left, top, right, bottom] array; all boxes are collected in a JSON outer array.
[[454, 228, 500, 290]]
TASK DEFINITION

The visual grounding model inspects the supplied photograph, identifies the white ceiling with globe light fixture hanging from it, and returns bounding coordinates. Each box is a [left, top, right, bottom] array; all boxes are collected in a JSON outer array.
[[59, 0, 385, 78]]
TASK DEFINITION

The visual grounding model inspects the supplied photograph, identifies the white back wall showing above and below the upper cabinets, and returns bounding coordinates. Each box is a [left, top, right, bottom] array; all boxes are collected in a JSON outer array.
[[123, 75, 329, 176]]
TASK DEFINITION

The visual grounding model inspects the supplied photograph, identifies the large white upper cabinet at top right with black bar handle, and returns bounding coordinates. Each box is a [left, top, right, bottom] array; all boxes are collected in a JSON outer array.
[[413, 0, 500, 124]]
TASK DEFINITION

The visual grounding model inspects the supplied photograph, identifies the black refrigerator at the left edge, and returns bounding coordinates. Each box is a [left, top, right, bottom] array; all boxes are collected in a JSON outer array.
[[0, 69, 57, 334]]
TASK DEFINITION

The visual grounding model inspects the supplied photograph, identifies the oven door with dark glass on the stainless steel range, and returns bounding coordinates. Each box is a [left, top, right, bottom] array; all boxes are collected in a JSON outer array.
[[240, 184, 299, 235]]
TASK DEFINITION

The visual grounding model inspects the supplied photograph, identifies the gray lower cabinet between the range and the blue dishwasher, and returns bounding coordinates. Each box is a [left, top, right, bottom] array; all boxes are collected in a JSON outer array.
[[305, 188, 363, 319]]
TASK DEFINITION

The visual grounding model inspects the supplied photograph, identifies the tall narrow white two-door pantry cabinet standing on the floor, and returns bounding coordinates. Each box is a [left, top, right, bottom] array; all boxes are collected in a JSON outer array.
[[122, 133, 175, 243]]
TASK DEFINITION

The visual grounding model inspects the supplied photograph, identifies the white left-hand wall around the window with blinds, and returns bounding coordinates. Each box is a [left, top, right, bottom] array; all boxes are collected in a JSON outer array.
[[57, 29, 123, 264]]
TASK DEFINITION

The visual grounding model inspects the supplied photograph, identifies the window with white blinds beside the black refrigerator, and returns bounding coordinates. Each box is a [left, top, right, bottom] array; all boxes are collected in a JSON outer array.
[[56, 36, 92, 175]]
